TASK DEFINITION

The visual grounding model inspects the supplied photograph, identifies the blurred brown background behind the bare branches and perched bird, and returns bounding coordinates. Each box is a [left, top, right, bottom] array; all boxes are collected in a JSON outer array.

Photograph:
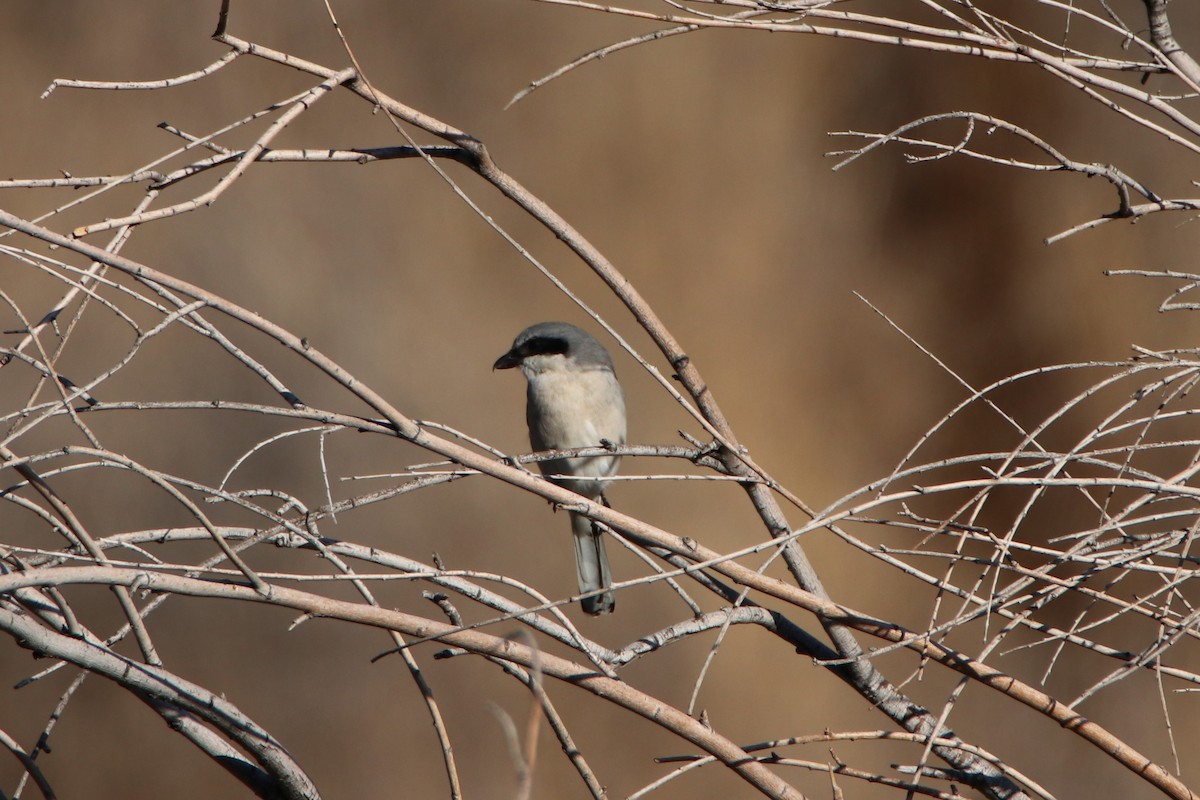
[[0, 0, 1200, 799]]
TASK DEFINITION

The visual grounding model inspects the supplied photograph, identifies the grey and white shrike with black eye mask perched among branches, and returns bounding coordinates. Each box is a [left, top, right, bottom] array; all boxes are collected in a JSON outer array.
[[492, 323, 625, 614]]
